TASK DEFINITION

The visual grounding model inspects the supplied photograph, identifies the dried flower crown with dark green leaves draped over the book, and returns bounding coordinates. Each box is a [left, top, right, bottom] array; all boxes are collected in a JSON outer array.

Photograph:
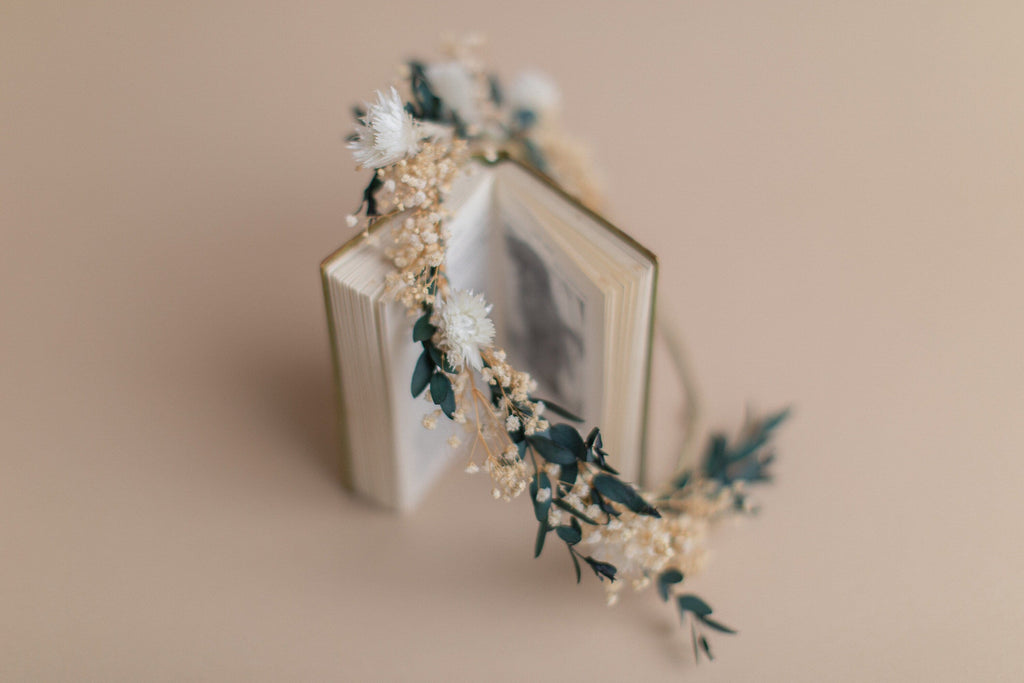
[[339, 37, 787, 659]]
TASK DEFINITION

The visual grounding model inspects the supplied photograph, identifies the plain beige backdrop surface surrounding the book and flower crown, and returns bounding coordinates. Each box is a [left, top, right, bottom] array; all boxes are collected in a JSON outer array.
[[0, 0, 1024, 682]]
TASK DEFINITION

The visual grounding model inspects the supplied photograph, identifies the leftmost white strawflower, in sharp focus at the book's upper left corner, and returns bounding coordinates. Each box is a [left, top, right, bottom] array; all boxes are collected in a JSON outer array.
[[348, 86, 422, 168]]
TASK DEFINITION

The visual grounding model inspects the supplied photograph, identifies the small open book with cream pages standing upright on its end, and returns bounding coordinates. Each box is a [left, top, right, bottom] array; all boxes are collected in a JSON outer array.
[[321, 160, 657, 509]]
